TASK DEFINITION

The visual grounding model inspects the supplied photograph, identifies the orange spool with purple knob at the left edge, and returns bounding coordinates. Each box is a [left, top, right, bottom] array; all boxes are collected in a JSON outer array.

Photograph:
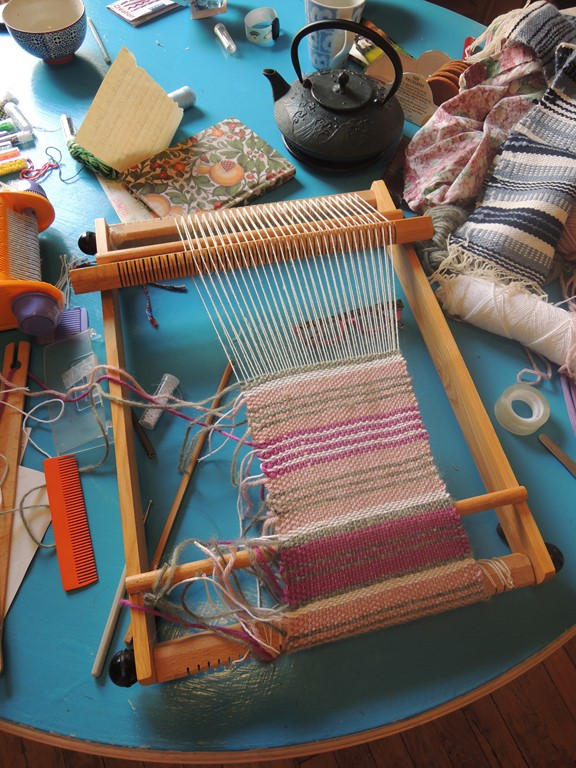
[[0, 185, 64, 336]]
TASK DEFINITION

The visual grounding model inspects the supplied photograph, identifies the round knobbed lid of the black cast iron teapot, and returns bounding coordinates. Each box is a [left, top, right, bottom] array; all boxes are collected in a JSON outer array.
[[302, 69, 374, 112]]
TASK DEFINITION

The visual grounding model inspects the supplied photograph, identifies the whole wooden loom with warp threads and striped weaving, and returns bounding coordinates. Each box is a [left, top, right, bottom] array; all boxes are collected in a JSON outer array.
[[71, 181, 554, 683]]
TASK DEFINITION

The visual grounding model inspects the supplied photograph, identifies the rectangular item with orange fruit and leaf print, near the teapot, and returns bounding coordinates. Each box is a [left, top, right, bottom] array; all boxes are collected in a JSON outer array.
[[122, 118, 296, 216]]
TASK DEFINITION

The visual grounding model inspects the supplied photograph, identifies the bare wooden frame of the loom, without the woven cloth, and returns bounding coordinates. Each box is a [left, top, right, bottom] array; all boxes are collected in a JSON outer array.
[[71, 182, 555, 684]]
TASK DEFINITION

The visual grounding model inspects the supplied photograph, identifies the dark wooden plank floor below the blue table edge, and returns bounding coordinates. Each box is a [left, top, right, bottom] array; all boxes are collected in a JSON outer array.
[[0, 632, 576, 768]]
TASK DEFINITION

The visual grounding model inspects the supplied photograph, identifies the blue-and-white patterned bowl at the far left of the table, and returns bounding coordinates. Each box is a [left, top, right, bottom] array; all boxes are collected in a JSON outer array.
[[4, 0, 86, 64]]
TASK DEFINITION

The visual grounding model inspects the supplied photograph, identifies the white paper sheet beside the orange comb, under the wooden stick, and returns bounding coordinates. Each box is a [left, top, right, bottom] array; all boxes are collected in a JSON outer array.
[[6, 467, 50, 613]]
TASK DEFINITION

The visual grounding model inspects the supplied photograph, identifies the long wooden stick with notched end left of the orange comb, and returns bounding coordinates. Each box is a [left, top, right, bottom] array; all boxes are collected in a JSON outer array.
[[0, 341, 30, 672]]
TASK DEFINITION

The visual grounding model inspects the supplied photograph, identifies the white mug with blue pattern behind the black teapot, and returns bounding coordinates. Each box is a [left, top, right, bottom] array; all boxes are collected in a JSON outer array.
[[306, 0, 366, 69]]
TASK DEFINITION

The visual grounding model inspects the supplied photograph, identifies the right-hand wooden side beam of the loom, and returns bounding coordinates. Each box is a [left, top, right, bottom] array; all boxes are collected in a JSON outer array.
[[372, 181, 556, 584]]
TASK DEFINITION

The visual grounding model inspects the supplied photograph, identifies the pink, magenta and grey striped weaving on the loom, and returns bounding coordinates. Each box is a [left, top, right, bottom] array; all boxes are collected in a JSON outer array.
[[245, 353, 487, 651]]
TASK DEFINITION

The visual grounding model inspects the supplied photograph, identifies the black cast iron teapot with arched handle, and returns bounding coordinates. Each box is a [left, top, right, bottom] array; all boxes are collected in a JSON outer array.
[[263, 19, 404, 170]]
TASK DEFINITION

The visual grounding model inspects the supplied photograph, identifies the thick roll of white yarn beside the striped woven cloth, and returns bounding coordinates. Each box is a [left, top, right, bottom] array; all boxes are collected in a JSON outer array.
[[437, 275, 576, 370]]
